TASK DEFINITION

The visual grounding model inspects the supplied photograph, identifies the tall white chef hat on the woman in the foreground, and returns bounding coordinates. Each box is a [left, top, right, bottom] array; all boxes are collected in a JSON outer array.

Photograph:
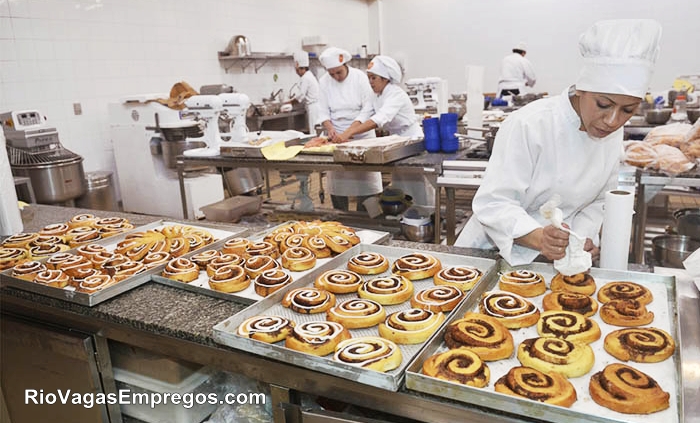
[[576, 19, 661, 98]]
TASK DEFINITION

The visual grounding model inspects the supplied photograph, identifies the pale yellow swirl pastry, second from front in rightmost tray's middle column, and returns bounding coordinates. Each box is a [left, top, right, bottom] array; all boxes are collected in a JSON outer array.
[[518, 338, 595, 377]]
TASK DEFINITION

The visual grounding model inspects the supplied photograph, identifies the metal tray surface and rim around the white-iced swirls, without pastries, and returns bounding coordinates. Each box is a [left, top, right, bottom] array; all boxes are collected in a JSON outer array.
[[213, 244, 496, 391]]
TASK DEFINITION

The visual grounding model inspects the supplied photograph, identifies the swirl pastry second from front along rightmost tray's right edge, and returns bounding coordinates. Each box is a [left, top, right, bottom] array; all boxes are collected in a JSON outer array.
[[603, 328, 676, 363]]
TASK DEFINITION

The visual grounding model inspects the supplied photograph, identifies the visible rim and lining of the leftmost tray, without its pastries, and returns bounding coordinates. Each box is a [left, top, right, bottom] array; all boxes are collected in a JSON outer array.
[[0, 220, 247, 307]]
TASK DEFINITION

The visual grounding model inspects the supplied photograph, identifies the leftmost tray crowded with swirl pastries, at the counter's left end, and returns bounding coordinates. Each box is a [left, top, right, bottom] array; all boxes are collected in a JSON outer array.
[[0, 220, 246, 306]]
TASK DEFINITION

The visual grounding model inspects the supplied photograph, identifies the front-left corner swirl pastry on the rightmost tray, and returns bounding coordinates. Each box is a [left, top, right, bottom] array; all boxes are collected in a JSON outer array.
[[423, 348, 491, 388]]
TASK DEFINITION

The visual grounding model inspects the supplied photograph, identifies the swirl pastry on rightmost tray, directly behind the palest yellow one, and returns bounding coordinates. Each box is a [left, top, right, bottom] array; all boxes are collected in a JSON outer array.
[[537, 311, 600, 344]]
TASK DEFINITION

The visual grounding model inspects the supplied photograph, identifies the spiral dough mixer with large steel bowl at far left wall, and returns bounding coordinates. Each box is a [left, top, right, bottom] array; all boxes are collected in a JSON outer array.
[[0, 110, 86, 204]]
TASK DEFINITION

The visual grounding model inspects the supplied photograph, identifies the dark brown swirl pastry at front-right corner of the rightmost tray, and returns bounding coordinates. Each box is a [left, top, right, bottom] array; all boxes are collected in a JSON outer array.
[[588, 363, 670, 414]]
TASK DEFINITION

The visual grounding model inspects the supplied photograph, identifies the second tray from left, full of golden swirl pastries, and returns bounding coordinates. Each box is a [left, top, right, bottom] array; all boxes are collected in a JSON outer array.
[[153, 220, 389, 304]]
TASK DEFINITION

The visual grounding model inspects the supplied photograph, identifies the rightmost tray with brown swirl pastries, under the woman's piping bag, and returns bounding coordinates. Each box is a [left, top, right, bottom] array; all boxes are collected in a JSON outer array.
[[406, 261, 683, 423]]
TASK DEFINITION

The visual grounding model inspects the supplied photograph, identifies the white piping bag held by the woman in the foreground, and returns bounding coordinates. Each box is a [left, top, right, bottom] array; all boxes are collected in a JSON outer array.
[[540, 194, 593, 276]]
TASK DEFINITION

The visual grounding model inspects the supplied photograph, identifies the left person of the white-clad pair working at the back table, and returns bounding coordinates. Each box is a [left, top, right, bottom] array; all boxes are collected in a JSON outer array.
[[319, 47, 382, 211]]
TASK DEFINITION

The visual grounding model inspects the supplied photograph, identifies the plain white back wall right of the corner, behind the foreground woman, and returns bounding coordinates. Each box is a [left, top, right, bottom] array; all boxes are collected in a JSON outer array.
[[378, 0, 700, 94]]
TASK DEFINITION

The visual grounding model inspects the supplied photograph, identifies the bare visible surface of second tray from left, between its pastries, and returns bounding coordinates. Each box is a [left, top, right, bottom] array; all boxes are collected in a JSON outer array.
[[153, 222, 391, 304]]
